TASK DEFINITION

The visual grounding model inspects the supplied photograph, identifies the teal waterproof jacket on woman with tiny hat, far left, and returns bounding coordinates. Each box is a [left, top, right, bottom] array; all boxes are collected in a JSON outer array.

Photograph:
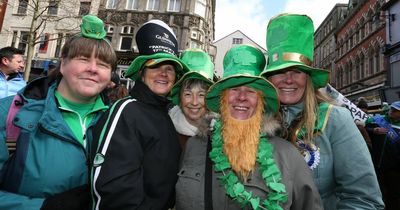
[[0, 78, 107, 210]]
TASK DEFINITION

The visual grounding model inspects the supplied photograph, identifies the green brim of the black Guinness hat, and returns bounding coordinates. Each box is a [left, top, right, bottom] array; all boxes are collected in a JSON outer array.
[[125, 53, 188, 81]]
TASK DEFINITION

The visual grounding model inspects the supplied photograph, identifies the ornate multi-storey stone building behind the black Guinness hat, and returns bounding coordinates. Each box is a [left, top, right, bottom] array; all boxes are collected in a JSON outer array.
[[98, 0, 216, 86]]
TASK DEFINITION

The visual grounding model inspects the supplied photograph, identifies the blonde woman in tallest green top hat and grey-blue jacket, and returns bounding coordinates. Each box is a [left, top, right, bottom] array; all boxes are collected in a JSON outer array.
[[261, 14, 384, 210]]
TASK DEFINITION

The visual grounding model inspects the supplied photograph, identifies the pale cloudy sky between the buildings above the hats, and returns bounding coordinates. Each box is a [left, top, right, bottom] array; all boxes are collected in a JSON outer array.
[[215, 0, 349, 48]]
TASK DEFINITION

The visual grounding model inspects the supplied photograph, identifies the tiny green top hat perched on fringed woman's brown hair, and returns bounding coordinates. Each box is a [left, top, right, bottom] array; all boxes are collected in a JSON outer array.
[[80, 15, 107, 39]]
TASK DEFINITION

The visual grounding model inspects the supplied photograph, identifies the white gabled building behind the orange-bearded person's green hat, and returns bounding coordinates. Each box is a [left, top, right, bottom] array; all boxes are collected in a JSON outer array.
[[214, 30, 266, 78]]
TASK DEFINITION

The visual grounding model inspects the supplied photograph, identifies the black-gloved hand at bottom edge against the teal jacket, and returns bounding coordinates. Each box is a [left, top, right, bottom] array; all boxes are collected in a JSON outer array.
[[40, 185, 90, 210]]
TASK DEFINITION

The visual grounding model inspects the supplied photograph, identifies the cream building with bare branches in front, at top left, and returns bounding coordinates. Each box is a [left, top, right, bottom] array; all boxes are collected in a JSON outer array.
[[0, 0, 100, 77]]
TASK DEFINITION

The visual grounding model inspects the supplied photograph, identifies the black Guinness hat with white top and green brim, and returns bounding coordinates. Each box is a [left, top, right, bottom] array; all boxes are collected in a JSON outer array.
[[125, 20, 187, 80]]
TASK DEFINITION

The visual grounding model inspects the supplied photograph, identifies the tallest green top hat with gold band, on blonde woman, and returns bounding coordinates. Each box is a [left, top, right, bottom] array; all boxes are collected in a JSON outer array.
[[261, 14, 329, 88]]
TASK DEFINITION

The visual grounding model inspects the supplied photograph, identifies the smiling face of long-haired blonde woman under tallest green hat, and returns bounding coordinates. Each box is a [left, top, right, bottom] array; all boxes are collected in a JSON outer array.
[[268, 68, 307, 105]]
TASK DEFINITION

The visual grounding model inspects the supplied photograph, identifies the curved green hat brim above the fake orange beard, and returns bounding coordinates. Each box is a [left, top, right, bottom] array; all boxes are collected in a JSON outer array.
[[206, 75, 279, 113]]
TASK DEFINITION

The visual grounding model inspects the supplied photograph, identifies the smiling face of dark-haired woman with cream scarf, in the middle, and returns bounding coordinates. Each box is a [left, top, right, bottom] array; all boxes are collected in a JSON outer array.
[[180, 85, 207, 126]]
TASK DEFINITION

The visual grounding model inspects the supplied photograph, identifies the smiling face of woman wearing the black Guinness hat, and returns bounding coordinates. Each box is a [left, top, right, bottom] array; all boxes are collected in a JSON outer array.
[[142, 63, 176, 97]]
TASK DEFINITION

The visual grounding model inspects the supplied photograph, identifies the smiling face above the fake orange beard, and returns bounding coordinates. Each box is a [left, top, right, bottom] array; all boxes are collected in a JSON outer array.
[[227, 86, 259, 120]]
